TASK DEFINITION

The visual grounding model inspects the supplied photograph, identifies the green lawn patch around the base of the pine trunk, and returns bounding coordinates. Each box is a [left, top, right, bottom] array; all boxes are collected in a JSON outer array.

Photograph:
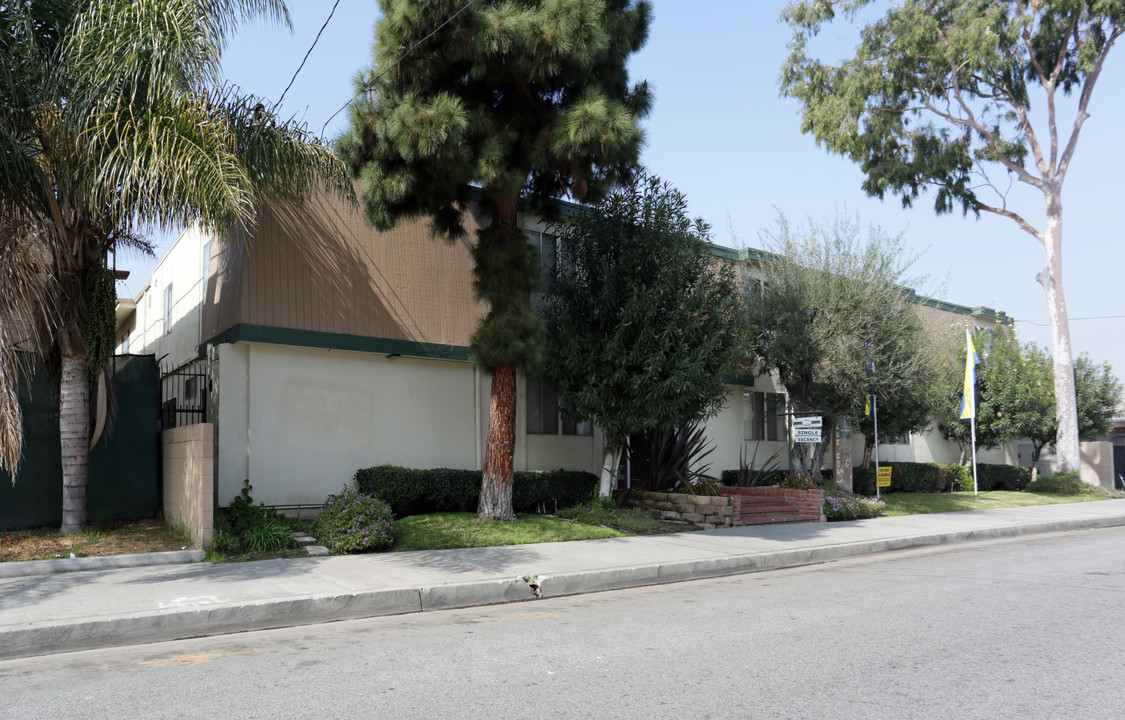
[[392, 513, 628, 552]]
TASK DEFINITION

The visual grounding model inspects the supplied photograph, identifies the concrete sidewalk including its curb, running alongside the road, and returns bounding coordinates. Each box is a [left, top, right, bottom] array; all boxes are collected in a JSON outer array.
[[0, 500, 1125, 660]]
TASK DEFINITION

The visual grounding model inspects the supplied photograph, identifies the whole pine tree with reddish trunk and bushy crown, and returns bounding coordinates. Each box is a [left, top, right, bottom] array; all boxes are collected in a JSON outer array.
[[338, 0, 650, 520]]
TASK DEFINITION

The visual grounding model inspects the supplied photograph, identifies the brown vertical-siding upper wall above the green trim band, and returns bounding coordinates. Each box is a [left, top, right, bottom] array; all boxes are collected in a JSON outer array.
[[204, 181, 485, 347]]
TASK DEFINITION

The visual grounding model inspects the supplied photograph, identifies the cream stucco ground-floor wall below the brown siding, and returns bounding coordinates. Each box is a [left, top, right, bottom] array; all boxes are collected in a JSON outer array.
[[213, 342, 602, 505]]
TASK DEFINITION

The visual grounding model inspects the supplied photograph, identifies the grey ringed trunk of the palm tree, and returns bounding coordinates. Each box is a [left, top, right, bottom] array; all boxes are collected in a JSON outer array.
[[59, 323, 90, 534]]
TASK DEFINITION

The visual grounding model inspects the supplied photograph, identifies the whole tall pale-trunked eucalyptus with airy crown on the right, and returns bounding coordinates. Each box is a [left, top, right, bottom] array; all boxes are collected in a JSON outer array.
[[781, 0, 1125, 470]]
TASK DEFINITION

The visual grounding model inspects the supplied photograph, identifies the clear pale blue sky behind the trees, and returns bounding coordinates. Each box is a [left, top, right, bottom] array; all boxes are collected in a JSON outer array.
[[118, 0, 1125, 377]]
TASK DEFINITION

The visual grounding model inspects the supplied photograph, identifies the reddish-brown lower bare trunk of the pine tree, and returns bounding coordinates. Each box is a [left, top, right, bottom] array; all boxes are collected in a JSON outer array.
[[477, 365, 515, 520]]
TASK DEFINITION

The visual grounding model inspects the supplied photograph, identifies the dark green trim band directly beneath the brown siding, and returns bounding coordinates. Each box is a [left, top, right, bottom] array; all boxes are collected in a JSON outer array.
[[199, 323, 469, 360]]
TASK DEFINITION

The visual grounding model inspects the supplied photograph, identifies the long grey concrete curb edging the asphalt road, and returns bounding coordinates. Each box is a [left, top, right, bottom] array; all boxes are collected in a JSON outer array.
[[0, 518, 1125, 660]]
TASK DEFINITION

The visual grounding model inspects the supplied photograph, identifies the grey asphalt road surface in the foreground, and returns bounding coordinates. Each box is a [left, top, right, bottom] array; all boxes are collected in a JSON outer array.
[[0, 528, 1125, 720]]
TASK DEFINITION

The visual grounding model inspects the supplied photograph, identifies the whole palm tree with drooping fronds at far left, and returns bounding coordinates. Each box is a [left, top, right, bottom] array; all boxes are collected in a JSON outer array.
[[0, 0, 352, 533]]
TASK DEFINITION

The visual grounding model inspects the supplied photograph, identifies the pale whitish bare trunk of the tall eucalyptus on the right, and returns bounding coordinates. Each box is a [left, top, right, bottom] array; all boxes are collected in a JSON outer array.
[[1036, 190, 1080, 473]]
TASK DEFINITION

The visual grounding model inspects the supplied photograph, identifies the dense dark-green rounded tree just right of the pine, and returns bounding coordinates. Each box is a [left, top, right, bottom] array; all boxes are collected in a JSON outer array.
[[545, 174, 749, 495]]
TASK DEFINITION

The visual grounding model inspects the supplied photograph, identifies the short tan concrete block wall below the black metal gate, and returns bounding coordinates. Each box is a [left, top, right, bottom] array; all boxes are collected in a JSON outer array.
[[160, 423, 215, 547]]
